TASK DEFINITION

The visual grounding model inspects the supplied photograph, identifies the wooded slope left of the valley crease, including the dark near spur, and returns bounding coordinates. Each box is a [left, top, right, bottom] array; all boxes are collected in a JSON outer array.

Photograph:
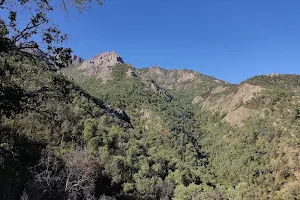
[[0, 52, 222, 199]]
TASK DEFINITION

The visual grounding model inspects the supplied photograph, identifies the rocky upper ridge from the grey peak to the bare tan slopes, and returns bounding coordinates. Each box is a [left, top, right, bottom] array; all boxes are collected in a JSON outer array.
[[64, 52, 264, 125]]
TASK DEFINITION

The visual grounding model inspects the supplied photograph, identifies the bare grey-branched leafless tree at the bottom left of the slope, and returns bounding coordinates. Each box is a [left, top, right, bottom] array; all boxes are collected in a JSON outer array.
[[28, 149, 102, 200]]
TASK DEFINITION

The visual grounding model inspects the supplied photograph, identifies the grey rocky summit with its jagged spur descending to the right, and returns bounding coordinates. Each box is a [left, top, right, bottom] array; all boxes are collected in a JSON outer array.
[[64, 52, 172, 101]]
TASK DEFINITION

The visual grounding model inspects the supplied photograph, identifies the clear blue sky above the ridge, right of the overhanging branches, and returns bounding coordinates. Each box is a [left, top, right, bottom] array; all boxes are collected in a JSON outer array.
[[14, 0, 300, 83]]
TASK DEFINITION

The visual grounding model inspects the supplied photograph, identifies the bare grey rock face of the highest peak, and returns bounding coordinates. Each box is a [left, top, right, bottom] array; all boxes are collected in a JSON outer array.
[[78, 51, 124, 81]]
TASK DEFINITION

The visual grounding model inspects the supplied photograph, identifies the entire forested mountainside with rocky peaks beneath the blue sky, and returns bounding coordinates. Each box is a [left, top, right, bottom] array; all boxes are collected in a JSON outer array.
[[0, 48, 300, 200]]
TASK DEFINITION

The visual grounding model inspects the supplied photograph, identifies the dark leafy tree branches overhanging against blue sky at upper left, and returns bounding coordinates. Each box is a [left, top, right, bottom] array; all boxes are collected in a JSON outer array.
[[0, 0, 103, 67]]
